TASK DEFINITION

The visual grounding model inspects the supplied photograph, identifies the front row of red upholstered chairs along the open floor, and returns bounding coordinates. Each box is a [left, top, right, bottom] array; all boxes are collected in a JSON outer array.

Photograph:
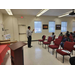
[[39, 36, 75, 63]]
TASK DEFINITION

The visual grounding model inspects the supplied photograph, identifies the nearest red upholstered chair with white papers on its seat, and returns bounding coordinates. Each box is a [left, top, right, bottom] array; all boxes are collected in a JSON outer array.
[[56, 41, 74, 63]]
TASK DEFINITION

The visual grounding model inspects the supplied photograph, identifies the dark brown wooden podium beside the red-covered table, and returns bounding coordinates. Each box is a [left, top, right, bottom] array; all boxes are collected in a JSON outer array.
[[9, 42, 26, 65]]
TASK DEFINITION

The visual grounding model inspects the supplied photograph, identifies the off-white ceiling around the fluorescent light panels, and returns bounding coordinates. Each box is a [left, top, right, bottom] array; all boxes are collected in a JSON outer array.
[[0, 9, 72, 16]]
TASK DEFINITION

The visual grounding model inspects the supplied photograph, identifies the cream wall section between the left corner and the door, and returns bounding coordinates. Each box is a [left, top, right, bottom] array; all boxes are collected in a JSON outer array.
[[3, 15, 19, 40]]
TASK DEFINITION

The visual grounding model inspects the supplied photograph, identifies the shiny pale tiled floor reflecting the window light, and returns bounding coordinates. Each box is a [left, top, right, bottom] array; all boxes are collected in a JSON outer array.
[[2, 42, 75, 65]]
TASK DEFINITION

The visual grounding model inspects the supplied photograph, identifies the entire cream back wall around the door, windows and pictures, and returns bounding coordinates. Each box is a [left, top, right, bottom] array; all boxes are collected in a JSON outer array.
[[3, 15, 74, 40]]
